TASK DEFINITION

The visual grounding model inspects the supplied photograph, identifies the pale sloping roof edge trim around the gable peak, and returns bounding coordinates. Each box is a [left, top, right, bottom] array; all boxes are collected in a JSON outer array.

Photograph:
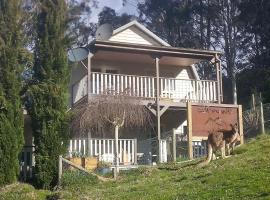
[[112, 20, 171, 47]]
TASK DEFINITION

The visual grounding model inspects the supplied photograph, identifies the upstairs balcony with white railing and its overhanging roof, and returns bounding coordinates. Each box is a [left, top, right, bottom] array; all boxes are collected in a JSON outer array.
[[69, 41, 222, 105]]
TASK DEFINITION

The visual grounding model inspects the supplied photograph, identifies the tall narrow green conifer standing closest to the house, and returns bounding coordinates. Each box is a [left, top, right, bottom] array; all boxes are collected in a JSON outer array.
[[28, 0, 70, 188]]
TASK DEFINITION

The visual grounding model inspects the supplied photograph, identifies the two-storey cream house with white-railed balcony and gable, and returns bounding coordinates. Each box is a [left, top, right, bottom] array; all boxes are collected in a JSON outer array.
[[69, 21, 223, 166]]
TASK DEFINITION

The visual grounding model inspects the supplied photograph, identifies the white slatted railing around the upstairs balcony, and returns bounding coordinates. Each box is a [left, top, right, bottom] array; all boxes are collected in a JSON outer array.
[[72, 72, 217, 103]]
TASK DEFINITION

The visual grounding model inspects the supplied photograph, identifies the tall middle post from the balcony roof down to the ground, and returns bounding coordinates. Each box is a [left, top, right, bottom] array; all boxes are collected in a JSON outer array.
[[155, 57, 162, 162]]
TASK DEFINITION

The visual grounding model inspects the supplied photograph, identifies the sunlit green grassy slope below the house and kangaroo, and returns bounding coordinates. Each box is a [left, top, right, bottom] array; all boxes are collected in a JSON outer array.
[[0, 136, 270, 200]]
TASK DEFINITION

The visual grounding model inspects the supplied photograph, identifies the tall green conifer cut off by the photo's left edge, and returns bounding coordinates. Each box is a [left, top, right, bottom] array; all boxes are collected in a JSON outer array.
[[0, 0, 23, 185]]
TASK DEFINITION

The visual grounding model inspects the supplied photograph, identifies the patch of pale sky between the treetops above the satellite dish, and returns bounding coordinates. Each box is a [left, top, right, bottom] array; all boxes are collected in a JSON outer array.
[[91, 0, 138, 22]]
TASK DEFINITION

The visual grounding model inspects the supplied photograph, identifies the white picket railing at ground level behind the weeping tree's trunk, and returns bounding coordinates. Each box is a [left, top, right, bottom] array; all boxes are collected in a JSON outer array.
[[69, 138, 137, 164]]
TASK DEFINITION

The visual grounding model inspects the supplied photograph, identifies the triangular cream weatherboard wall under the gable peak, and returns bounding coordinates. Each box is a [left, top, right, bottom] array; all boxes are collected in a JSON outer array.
[[109, 26, 161, 46]]
